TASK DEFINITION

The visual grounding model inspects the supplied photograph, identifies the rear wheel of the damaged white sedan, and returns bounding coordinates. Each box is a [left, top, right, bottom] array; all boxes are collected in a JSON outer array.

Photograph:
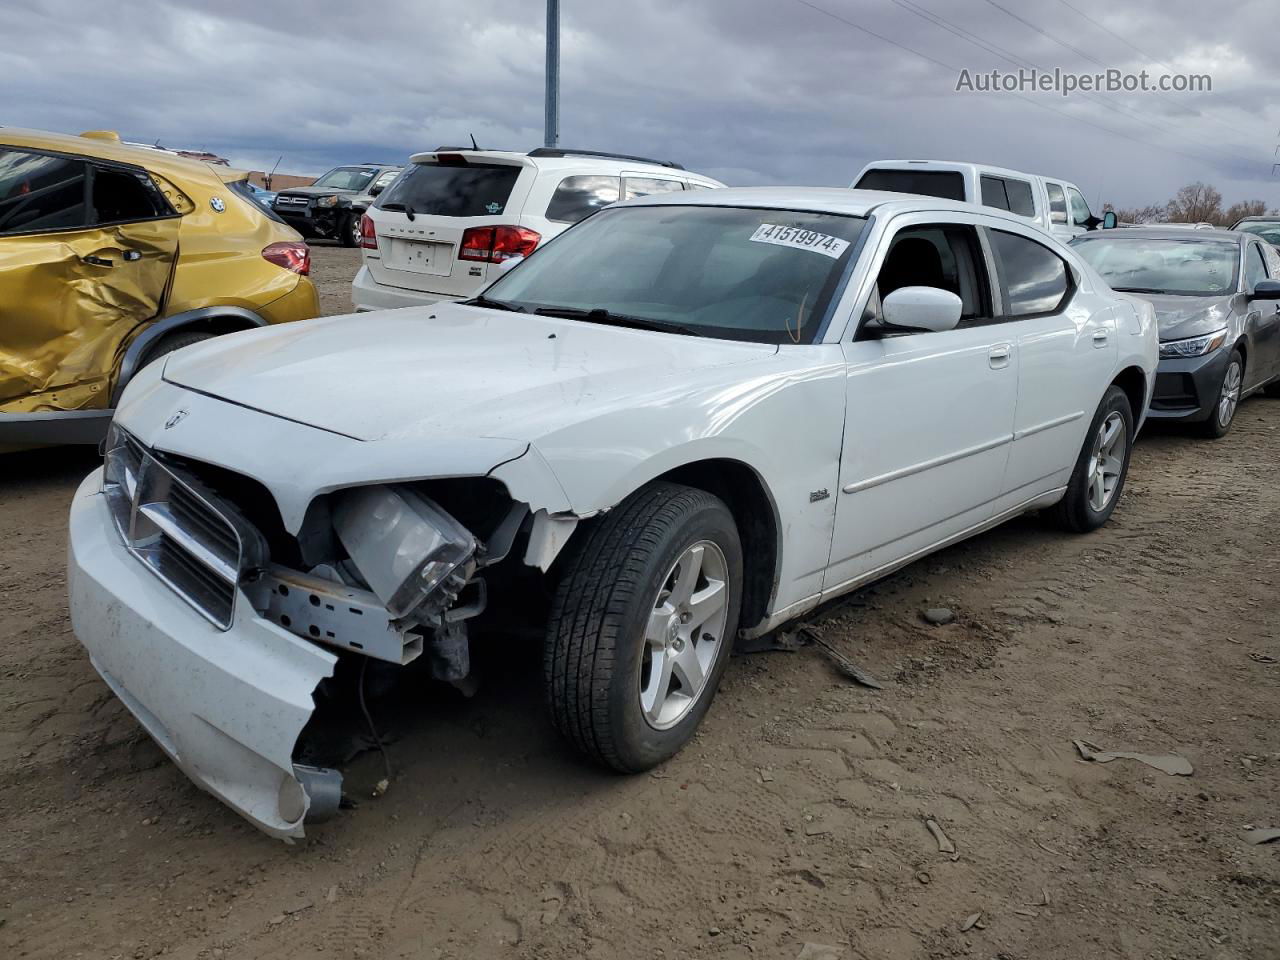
[[1057, 385, 1134, 534]]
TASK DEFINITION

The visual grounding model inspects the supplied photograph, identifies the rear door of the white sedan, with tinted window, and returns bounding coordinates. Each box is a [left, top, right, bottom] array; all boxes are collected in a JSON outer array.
[[987, 224, 1116, 512]]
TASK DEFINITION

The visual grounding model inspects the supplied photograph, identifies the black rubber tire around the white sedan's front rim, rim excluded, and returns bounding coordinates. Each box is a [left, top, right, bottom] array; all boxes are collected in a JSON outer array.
[[543, 483, 742, 773]]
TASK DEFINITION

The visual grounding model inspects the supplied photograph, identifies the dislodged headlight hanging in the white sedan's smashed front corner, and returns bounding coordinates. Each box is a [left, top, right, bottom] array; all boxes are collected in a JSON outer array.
[[333, 486, 476, 620]]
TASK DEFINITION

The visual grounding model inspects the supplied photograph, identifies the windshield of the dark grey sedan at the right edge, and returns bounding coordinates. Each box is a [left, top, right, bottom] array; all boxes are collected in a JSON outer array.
[[1071, 236, 1240, 297]]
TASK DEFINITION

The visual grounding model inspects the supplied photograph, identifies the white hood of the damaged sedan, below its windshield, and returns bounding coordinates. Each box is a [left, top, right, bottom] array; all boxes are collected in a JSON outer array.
[[164, 303, 777, 440]]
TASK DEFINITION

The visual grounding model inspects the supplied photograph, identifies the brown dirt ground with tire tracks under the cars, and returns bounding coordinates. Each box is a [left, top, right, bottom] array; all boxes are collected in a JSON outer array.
[[0, 247, 1280, 960]]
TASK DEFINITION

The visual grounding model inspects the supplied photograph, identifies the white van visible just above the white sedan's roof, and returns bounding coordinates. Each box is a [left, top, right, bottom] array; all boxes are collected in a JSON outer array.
[[849, 160, 1102, 242]]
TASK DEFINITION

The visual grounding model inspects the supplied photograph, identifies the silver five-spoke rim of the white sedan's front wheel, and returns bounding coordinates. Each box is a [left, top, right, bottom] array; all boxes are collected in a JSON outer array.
[[640, 540, 728, 730]]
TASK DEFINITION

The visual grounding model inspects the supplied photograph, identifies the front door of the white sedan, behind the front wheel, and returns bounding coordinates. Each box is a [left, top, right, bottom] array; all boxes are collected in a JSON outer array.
[[824, 214, 1018, 593]]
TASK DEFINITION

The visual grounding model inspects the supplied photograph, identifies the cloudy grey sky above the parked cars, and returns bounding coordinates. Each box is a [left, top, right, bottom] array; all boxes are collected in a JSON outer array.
[[0, 0, 1280, 206]]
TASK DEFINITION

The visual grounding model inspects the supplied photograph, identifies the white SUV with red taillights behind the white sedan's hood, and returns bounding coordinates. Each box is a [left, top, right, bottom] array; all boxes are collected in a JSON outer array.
[[351, 147, 724, 310]]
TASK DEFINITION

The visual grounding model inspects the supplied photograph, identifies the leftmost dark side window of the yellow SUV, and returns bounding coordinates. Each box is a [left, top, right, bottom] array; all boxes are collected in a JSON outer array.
[[0, 147, 86, 233]]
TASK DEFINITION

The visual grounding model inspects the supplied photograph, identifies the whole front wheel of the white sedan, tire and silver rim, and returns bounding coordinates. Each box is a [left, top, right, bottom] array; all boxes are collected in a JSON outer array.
[[544, 483, 742, 773]]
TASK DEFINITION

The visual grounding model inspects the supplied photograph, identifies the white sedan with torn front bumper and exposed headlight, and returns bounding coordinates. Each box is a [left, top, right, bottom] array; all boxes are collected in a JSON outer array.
[[69, 188, 1158, 837]]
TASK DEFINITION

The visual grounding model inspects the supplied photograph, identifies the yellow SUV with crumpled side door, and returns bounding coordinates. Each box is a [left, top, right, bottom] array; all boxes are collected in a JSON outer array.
[[0, 128, 320, 452]]
